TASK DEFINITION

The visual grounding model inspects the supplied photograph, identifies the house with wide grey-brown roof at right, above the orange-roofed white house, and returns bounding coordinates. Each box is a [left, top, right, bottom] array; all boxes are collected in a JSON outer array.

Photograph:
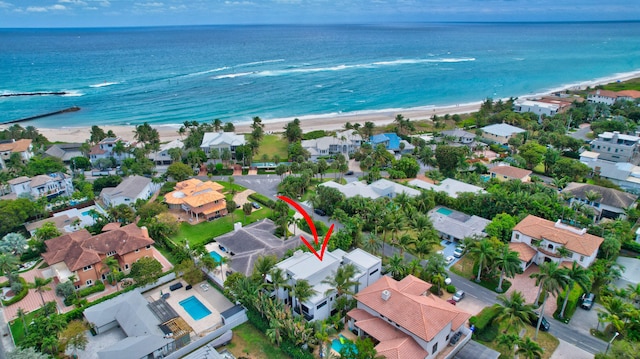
[[562, 182, 638, 220]]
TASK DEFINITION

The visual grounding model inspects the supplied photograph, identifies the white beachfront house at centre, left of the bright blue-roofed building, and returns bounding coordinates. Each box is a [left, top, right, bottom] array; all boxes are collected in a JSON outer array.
[[301, 130, 362, 161]]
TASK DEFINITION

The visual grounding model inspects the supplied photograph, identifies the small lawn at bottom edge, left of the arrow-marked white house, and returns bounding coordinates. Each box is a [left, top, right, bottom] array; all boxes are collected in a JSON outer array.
[[219, 323, 289, 359]]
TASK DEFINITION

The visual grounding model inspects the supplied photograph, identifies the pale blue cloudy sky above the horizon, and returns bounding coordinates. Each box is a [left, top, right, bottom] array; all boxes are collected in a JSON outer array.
[[0, 0, 640, 28]]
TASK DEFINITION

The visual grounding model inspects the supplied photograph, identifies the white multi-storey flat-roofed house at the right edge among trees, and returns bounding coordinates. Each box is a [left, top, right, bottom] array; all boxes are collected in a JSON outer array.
[[591, 131, 640, 164]]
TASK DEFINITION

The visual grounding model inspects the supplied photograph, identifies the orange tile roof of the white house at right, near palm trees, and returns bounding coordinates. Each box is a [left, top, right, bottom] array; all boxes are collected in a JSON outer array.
[[513, 215, 604, 256]]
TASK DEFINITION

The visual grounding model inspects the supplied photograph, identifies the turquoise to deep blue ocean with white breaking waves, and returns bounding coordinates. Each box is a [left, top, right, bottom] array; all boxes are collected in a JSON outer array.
[[0, 22, 640, 127]]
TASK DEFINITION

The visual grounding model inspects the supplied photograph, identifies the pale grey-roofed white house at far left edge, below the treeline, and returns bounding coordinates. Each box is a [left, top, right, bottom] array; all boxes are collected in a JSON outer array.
[[7, 172, 73, 199]]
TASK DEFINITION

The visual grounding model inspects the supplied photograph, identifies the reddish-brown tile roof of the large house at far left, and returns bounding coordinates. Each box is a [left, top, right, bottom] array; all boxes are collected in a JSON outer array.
[[42, 223, 154, 271]]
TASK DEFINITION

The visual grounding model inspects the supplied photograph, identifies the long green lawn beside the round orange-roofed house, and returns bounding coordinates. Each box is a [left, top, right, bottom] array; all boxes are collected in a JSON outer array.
[[171, 207, 272, 248]]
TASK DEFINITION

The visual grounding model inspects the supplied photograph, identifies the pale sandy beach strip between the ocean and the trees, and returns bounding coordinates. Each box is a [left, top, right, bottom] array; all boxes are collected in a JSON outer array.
[[10, 69, 640, 142]]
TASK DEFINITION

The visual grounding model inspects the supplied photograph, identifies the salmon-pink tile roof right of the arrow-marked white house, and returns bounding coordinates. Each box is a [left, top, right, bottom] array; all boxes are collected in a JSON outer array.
[[355, 275, 471, 341]]
